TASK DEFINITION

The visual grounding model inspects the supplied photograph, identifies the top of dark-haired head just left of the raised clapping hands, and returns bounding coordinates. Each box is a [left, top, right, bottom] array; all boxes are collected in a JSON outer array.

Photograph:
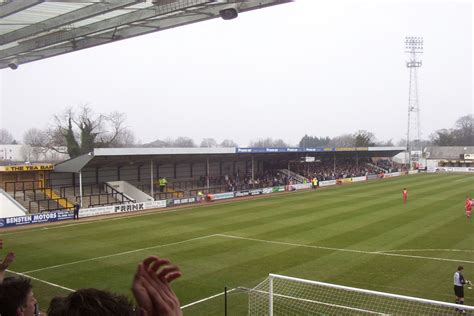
[[47, 289, 136, 316]]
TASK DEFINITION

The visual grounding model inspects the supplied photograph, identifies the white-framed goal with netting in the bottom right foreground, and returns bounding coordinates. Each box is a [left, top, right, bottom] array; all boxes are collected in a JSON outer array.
[[249, 274, 474, 316]]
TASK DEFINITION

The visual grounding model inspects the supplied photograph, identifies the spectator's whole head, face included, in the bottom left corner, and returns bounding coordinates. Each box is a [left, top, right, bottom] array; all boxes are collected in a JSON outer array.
[[0, 277, 38, 316]]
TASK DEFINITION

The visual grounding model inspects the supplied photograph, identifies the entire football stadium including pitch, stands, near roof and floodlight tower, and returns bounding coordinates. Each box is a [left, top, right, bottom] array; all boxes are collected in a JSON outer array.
[[0, 0, 474, 316]]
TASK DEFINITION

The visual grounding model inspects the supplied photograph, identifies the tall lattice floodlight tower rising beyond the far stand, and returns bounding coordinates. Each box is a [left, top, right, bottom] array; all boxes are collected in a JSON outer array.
[[405, 37, 423, 166]]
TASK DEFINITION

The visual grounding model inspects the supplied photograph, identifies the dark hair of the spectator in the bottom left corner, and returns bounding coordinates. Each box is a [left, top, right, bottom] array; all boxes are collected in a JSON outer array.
[[0, 277, 33, 316]]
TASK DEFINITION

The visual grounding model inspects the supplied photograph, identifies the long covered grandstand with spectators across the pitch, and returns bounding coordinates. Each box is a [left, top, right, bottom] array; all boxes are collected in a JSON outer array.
[[0, 147, 404, 217]]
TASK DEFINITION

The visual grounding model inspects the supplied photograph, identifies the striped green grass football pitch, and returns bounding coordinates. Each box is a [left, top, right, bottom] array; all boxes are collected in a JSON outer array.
[[0, 174, 474, 315]]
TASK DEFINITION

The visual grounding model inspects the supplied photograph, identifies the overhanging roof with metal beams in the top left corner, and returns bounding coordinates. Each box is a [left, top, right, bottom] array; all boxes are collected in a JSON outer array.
[[0, 0, 292, 69]]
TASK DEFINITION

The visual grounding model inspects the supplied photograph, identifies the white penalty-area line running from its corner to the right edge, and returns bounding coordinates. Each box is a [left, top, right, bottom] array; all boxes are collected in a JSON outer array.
[[216, 234, 474, 264]]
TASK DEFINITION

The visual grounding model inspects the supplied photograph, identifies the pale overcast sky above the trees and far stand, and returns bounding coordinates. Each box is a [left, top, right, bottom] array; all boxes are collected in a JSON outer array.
[[0, 0, 473, 147]]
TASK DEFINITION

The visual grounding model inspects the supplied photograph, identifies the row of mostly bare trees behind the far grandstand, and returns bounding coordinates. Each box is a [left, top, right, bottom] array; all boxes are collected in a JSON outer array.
[[0, 105, 474, 158]]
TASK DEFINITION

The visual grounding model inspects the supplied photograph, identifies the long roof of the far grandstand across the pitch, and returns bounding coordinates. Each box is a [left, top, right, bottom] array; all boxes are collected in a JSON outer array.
[[54, 147, 405, 173]]
